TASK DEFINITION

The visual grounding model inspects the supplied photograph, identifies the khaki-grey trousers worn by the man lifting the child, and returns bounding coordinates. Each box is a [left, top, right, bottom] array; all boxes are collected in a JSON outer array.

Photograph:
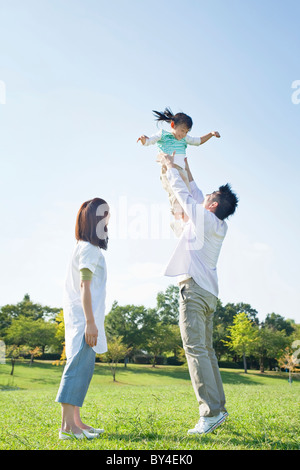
[[179, 278, 225, 416]]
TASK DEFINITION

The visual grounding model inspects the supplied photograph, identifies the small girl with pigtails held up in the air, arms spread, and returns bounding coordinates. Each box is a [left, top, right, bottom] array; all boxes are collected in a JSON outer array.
[[137, 108, 220, 230]]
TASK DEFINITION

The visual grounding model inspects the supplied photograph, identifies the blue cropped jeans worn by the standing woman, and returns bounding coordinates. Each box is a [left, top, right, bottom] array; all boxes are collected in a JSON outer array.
[[55, 336, 96, 407]]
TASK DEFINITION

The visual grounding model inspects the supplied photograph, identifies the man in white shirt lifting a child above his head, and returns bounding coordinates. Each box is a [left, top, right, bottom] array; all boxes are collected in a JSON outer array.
[[164, 154, 238, 434]]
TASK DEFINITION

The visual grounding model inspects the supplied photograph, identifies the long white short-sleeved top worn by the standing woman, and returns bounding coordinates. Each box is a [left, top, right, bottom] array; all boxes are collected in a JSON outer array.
[[63, 241, 107, 359]]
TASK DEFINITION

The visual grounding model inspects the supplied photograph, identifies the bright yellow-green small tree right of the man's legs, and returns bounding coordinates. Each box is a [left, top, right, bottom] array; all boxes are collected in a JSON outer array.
[[225, 312, 258, 374]]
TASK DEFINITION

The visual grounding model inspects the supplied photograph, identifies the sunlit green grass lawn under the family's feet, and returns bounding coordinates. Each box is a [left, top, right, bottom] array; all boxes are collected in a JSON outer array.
[[0, 361, 300, 450]]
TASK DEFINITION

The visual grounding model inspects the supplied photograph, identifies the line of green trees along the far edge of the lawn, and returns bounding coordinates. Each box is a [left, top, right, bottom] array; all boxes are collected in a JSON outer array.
[[0, 285, 300, 375]]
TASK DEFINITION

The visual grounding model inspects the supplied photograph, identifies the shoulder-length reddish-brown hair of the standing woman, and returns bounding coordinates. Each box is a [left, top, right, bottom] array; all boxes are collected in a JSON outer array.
[[75, 197, 109, 250]]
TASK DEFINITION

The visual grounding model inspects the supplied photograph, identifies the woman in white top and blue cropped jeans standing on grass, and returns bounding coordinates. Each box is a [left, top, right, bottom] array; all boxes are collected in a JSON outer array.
[[56, 198, 109, 439]]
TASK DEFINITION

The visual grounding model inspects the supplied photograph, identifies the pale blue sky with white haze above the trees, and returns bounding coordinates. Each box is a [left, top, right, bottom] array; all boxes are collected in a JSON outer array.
[[0, 0, 300, 323]]
